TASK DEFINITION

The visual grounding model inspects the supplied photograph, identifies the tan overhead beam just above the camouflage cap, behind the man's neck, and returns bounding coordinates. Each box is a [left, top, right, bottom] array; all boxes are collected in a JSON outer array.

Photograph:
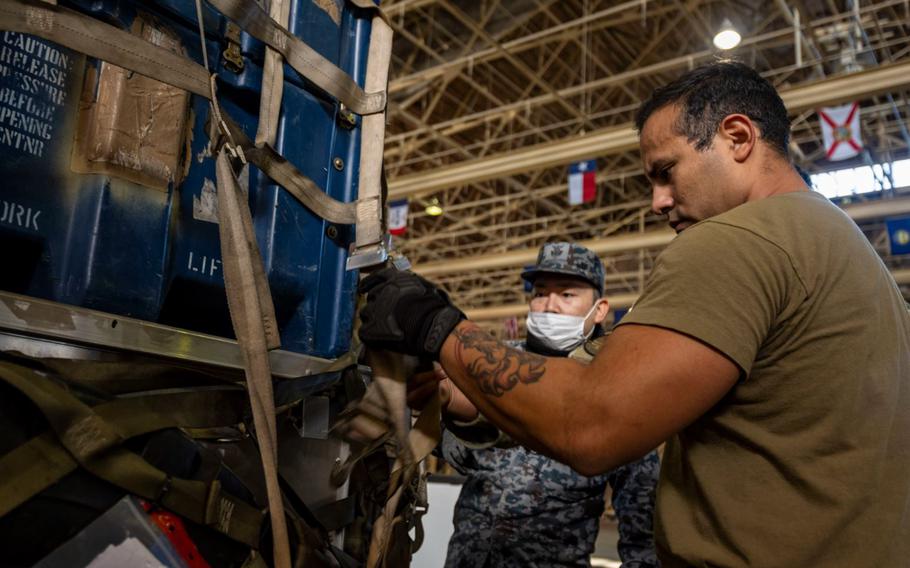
[[412, 193, 910, 276]]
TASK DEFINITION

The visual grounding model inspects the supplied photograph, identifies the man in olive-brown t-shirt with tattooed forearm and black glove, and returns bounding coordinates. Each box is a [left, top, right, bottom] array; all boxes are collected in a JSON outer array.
[[360, 62, 910, 568]]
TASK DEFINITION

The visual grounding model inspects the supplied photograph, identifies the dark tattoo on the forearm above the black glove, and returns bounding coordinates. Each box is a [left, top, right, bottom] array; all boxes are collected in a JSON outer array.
[[455, 327, 547, 396]]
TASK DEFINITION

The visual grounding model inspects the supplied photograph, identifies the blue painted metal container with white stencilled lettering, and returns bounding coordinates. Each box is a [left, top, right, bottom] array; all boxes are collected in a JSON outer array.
[[0, 0, 371, 357]]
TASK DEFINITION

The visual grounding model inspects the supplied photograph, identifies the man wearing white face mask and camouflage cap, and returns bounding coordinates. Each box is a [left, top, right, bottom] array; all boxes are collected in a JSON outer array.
[[410, 243, 659, 568]]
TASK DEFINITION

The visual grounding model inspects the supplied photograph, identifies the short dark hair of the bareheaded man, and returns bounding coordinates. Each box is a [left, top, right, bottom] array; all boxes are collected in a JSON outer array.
[[635, 61, 790, 158]]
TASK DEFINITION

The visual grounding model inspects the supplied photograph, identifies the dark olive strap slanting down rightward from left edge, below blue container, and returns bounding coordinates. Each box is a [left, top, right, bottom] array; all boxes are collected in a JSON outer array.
[[0, 363, 262, 547]]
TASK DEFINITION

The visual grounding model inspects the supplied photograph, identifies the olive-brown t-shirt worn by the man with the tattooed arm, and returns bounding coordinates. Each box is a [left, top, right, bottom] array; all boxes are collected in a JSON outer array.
[[622, 192, 910, 567]]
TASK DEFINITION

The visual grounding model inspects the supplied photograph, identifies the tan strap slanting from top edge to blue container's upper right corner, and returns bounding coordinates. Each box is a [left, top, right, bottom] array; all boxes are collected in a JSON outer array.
[[207, 0, 386, 115]]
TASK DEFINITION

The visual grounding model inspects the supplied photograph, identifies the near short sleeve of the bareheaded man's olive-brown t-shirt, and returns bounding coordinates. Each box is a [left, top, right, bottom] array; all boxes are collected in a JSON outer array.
[[619, 221, 799, 376]]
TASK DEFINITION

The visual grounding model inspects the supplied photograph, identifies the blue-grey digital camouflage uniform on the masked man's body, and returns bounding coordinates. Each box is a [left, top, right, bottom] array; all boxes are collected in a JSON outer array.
[[442, 345, 660, 568]]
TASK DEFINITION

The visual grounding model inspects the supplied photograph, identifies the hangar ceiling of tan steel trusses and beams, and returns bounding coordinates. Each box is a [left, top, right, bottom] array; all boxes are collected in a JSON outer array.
[[384, 0, 910, 330]]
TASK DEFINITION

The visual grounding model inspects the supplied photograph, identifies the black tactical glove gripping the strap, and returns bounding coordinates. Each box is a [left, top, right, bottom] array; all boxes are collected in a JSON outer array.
[[359, 268, 465, 359]]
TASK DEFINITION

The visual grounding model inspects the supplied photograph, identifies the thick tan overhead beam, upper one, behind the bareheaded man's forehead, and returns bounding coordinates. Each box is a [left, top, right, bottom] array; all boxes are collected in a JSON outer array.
[[389, 62, 910, 199]]
